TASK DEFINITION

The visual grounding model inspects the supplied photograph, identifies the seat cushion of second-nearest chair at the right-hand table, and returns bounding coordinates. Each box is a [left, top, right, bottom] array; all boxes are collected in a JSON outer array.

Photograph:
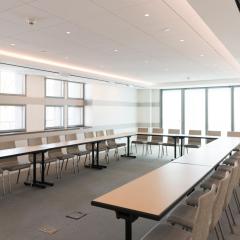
[[167, 205, 197, 229]]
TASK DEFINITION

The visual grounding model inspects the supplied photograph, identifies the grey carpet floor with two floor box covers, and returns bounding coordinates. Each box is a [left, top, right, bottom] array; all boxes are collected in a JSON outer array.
[[0, 147, 240, 240]]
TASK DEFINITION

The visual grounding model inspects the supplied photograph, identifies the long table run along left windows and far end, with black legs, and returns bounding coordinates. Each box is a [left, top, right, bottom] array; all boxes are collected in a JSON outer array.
[[0, 132, 216, 188]]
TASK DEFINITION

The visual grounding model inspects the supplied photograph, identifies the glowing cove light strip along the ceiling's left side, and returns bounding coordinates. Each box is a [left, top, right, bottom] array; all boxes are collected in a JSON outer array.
[[0, 49, 153, 86]]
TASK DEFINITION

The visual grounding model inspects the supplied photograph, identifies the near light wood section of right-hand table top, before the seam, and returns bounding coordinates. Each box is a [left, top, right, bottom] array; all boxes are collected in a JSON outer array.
[[92, 163, 212, 220]]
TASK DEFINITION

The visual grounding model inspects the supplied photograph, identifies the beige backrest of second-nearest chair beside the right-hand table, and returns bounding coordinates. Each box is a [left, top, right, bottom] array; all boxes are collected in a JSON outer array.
[[210, 172, 232, 230]]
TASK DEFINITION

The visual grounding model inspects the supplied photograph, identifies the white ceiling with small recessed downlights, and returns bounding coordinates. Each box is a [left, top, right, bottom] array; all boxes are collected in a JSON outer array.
[[0, 0, 240, 87]]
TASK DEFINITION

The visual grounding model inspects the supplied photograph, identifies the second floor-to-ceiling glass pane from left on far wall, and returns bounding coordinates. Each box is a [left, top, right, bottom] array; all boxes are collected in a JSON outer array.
[[185, 89, 205, 134]]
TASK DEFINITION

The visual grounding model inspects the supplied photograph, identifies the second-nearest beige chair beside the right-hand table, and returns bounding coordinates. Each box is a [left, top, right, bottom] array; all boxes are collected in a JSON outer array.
[[167, 172, 231, 239]]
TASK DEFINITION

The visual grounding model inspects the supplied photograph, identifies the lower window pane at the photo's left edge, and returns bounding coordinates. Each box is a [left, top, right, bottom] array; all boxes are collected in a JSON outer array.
[[0, 105, 26, 132]]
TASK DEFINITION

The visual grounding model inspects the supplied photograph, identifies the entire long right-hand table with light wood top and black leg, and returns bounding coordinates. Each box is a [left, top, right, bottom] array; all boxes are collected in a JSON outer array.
[[91, 137, 240, 240]]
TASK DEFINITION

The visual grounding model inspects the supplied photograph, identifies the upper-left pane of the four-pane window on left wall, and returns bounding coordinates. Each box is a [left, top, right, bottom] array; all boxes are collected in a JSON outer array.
[[46, 78, 64, 98]]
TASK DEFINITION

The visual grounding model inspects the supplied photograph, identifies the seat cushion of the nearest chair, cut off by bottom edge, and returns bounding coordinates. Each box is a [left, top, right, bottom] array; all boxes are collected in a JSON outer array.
[[142, 224, 192, 240]]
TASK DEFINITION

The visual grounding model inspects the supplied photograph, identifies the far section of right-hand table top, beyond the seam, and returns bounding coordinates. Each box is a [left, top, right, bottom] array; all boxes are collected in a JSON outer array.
[[172, 137, 240, 167]]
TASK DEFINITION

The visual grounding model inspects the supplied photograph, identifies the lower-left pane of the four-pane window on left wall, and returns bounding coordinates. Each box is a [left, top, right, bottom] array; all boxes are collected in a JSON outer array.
[[45, 106, 64, 128]]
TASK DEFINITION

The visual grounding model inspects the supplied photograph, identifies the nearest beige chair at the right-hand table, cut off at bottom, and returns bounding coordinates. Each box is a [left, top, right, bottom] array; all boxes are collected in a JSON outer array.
[[142, 186, 216, 240]]
